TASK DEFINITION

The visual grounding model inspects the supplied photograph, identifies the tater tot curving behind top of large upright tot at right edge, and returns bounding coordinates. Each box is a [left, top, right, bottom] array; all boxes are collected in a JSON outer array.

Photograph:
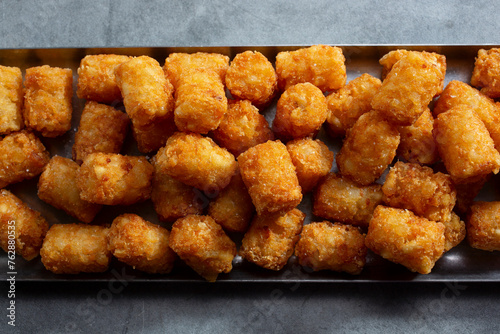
[[432, 80, 500, 149]]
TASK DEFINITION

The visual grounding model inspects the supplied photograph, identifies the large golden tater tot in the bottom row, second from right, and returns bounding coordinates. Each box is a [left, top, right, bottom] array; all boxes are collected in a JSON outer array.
[[365, 205, 445, 274]]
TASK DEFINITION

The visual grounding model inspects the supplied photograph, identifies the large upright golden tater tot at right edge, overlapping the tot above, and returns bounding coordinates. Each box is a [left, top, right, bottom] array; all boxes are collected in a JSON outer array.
[[432, 105, 500, 183]]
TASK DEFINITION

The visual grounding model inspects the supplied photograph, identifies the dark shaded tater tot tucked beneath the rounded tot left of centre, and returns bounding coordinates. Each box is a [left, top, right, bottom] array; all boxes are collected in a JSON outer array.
[[151, 159, 203, 222]]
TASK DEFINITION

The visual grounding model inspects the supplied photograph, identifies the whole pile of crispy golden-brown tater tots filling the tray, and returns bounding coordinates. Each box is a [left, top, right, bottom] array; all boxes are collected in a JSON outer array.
[[0, 45, 500, 281]]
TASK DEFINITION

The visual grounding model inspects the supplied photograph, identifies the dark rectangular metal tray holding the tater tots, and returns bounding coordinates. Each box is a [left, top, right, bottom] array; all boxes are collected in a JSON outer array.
[[0, 45, 500, 284]]
